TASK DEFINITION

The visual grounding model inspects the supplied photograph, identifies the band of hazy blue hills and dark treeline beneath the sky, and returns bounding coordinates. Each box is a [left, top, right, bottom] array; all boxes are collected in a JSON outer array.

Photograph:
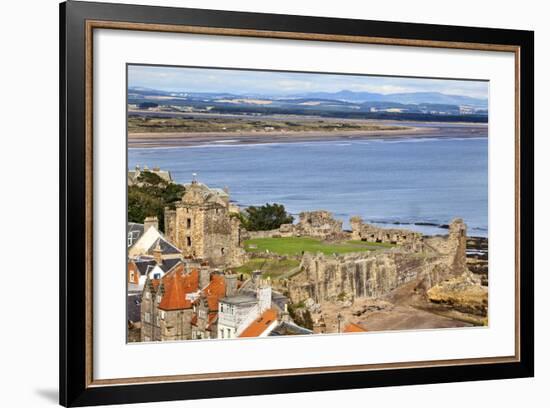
[[128, 87, 487, 122]]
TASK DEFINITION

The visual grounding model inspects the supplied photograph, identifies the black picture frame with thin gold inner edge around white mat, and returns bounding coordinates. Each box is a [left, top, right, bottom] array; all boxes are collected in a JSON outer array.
[[59, 1, 534, 406]]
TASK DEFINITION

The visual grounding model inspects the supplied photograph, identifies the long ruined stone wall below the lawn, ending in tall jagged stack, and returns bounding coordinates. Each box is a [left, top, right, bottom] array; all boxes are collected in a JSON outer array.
[[288, 220, 467, 303]]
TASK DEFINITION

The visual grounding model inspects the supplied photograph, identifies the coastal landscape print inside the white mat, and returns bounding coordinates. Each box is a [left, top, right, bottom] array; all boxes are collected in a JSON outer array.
[[127, 64, 490, 342]]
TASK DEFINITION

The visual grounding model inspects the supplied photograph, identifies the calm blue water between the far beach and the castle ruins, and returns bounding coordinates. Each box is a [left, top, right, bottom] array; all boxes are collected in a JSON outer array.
[[128, 138, 488, 236]]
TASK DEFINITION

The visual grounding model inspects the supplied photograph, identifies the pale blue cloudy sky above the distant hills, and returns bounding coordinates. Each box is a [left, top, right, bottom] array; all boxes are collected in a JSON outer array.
[[128, 65, 488, 99]]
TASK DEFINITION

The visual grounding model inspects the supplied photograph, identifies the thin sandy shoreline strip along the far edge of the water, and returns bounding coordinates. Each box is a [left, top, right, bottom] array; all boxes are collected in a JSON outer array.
[[128, 124, 487, 148]]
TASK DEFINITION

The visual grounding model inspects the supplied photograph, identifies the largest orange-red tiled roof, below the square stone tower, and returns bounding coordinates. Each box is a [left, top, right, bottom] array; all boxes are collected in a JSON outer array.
[[159, 266, 199, 310]]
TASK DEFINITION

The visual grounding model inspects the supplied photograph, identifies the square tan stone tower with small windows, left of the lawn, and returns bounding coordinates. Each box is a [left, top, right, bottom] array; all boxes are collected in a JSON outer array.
[[165, 180, 240, 266]]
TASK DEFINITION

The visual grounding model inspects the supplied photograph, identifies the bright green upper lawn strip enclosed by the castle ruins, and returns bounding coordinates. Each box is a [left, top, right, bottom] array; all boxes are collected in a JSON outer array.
[[244, 237, 394, 255]]
